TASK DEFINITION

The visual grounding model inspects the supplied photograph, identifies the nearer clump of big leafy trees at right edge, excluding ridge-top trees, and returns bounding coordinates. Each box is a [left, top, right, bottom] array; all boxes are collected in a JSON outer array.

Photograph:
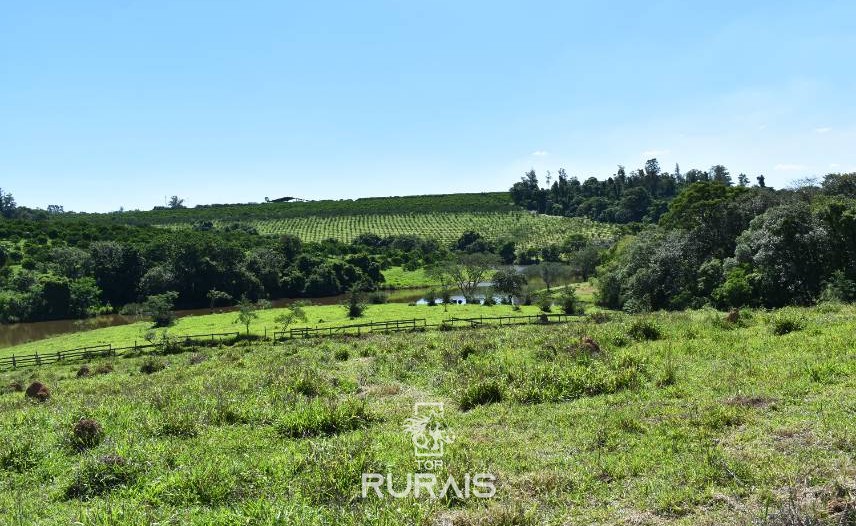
[[598, 173, 856, 311]]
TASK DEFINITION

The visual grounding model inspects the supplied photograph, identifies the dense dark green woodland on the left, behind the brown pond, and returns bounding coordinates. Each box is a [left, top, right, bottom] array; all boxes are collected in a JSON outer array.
[[0, 194, 454, 323]]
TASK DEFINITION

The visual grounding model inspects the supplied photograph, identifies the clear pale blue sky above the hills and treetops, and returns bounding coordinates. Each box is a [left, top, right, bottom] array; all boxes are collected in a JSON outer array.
[[0, 0, 856, 211]]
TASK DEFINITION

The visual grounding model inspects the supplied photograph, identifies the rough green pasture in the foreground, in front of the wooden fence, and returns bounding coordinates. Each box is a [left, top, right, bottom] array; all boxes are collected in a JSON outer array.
[[0, 306, 856, 525]]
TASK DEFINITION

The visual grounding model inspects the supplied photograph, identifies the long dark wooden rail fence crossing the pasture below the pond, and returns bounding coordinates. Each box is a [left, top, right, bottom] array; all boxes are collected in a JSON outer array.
[[0, 313, 574, 369]]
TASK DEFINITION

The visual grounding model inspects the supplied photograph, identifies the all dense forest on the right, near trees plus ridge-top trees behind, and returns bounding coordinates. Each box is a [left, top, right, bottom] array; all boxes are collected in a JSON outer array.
[[510, 163, 856, 312]]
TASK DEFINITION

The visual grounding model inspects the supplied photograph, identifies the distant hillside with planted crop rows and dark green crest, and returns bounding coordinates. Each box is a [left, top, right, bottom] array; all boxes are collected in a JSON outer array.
[[45, 192, 616, 248]]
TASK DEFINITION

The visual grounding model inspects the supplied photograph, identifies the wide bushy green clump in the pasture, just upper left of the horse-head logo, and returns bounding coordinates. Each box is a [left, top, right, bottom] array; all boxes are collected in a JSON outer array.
[[278, 399, 374, 438]]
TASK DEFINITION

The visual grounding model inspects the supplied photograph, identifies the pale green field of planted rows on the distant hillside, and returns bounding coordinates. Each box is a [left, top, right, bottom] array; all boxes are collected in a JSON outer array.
[[158, 212, 617, 247]]
